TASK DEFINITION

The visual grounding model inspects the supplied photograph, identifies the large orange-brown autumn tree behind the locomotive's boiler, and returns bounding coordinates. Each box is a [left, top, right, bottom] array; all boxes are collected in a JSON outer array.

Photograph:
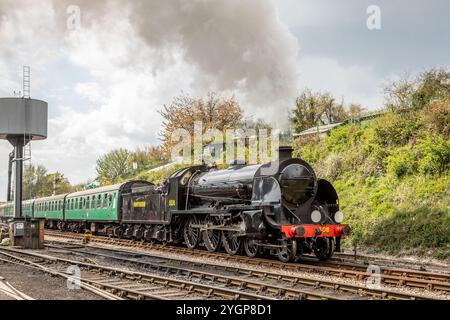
[[159, 92, 243, 154]]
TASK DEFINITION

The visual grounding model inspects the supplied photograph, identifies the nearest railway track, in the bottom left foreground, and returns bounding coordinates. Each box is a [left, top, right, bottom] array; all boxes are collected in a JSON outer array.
[[0, 248, 280, 300]]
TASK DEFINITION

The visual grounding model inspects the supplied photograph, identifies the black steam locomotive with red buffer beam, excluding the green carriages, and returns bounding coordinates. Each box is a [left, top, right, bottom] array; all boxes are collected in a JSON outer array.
[[124, 147, 350, 262]]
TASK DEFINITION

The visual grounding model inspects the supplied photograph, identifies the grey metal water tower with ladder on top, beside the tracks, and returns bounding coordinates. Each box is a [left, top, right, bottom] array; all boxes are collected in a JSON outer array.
[[0, 68, 48, 248]]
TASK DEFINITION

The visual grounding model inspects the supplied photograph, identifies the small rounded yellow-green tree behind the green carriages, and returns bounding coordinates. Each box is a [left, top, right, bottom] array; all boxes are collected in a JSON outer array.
[[96, 148, 132, 184]]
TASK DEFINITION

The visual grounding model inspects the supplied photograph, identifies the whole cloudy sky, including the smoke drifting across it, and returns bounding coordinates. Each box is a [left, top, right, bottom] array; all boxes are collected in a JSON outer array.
[[0, 0, 450, 199]]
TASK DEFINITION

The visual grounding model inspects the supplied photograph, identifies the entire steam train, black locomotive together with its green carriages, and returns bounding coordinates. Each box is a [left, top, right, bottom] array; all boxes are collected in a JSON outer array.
[[0, 147, 350, 262]]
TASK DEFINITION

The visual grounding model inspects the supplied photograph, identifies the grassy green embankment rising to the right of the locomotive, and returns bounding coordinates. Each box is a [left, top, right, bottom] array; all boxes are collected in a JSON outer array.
[[295, 100, 450, 259]]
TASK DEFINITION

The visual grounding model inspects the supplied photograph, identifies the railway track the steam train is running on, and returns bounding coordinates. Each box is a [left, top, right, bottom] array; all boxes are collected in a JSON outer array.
[[46, 231, 450, 293]]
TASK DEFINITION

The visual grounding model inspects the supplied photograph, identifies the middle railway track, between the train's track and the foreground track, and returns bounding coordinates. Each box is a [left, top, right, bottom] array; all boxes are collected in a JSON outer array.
[[47, 240, 446, 300]]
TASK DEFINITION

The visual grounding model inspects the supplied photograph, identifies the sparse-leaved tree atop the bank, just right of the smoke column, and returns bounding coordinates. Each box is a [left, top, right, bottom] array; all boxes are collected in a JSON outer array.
[[291, 89, 347, 131]]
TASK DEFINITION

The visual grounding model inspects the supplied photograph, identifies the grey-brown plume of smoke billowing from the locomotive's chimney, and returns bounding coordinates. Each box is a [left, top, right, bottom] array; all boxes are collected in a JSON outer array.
[[0, 0, 298, 125]]
